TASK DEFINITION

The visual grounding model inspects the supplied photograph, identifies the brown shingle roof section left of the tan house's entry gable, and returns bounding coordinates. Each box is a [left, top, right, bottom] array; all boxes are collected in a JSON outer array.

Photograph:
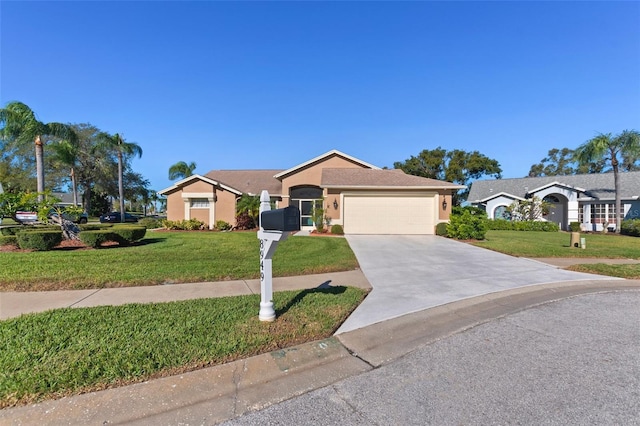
[[205, 169, 282, 196]]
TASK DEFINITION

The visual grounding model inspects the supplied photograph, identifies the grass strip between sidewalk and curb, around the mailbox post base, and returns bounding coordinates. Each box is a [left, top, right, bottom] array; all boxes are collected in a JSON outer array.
[[0, 284, 366, 408]]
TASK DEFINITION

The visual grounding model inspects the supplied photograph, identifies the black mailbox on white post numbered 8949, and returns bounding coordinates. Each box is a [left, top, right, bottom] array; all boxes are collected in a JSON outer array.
[[258, 190, 300, 321]]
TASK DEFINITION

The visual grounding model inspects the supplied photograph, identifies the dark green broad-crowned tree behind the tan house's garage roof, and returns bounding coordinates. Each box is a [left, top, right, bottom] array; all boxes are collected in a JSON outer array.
[[393, 147, 502, 206]]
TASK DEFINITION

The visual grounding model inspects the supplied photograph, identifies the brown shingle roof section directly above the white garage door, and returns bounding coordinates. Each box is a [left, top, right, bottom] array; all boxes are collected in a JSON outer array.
[[320, 169, 464, 189]]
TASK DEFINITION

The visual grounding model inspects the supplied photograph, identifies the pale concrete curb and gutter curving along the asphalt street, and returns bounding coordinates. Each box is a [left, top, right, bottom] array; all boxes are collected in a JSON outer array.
[[0, 280, 640, 425]]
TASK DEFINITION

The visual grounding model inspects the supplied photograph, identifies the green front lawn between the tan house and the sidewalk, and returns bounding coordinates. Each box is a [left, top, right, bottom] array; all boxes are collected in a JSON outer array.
[[0, 232, 358, 291]]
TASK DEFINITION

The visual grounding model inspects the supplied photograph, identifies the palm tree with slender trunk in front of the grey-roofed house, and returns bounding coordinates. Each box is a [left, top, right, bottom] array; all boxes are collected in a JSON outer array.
[[576, 130, 640, 233]]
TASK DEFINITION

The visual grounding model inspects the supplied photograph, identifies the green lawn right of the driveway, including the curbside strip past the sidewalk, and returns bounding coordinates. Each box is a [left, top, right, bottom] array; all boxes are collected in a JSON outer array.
[[473, 231, 640, 279]]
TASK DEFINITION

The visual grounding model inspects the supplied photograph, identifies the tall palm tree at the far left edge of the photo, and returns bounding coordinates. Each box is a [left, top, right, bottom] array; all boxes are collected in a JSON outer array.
[[0, 102, 77, 201]]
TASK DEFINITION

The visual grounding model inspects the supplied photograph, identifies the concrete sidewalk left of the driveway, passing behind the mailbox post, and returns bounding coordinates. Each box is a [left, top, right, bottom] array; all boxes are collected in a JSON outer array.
[[0, 269, 371, 320]]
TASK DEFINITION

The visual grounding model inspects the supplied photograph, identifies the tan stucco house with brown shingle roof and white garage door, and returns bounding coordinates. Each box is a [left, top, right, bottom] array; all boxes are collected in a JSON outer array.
[[158, 150, 465, 234]]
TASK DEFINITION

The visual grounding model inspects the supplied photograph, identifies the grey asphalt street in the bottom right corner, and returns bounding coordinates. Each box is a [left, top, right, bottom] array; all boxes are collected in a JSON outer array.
[[224, 291, 640, 425]]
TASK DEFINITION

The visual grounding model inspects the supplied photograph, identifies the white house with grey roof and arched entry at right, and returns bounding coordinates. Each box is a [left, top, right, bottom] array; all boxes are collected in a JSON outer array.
[[467, 172, 640, 231]]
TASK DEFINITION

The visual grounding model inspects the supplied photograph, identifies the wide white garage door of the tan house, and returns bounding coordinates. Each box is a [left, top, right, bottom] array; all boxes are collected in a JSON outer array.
[[343, 194, 437, 234]]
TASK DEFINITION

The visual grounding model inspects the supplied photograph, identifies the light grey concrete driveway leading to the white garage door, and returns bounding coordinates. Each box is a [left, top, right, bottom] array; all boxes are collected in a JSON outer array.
[[336, 235, 612, 334]]
